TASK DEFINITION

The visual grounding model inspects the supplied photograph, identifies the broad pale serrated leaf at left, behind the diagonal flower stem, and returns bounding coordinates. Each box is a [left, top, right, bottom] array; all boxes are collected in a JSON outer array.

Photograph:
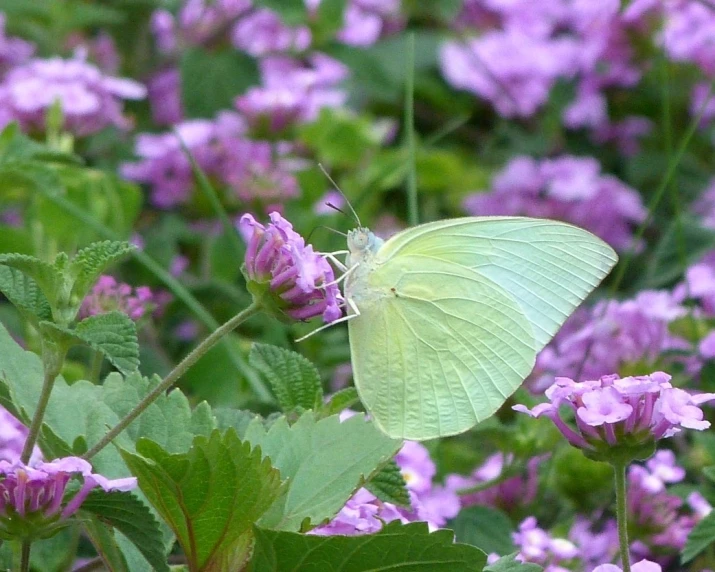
[[0, 324, 214, 478]]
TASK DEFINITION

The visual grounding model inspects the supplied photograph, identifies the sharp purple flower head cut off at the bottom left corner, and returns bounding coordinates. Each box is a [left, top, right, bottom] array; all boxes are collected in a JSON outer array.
[[0, 457, 137, 538]]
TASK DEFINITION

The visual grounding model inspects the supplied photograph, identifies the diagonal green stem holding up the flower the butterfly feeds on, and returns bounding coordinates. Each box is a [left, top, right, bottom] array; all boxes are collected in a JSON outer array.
[[82, 302, 261, 459]]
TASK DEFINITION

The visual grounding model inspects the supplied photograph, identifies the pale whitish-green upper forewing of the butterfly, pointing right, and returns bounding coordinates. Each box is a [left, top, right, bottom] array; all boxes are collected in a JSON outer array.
[[376, 217, 618, 352]]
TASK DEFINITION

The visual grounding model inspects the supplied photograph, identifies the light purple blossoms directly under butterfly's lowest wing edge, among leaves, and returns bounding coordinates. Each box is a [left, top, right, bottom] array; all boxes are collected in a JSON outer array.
[[310, 441, 460, 536]]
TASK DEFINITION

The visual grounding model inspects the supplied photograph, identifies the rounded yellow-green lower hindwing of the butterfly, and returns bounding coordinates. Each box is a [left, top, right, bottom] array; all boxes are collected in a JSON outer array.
[[348, 255, 536, 440]]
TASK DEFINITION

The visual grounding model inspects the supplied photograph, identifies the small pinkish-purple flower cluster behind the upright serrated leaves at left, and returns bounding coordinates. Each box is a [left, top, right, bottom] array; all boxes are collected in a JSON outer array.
[[79, 275, 156, 321]]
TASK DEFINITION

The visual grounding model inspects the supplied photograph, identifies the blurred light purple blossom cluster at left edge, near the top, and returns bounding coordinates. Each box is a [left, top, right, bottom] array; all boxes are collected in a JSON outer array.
[[0, 57, 146, 136]]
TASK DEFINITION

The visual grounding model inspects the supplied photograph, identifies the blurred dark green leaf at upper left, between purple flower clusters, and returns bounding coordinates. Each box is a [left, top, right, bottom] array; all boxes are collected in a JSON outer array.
[[179, 47, 259, 118]]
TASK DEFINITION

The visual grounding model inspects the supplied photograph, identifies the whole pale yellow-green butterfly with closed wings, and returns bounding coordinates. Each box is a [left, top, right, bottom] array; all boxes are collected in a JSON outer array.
[[344, 217, 618, 440]]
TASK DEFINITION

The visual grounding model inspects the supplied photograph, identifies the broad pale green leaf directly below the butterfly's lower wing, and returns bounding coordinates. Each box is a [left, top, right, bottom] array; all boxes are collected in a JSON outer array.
[[244, 412, 402, 531]]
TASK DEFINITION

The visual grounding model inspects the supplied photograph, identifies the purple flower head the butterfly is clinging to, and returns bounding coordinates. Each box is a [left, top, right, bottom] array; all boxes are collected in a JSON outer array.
[[239, 212, 342, 323]]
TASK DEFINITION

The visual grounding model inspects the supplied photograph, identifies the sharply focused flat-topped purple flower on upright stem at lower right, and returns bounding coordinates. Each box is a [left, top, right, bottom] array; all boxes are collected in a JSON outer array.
[[513, 372, 715, 461]]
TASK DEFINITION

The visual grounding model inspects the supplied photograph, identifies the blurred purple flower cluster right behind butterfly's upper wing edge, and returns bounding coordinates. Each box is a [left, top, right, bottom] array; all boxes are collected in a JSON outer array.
[[464, 155, 646, 249]]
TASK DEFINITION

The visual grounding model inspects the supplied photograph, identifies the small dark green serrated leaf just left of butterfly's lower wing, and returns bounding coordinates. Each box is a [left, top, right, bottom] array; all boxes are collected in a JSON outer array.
[[248, 344, 323, 413]]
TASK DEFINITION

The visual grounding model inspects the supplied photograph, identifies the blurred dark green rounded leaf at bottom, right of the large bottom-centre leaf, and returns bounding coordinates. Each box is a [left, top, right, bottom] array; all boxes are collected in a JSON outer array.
[[449, 506, 514, 554]]
